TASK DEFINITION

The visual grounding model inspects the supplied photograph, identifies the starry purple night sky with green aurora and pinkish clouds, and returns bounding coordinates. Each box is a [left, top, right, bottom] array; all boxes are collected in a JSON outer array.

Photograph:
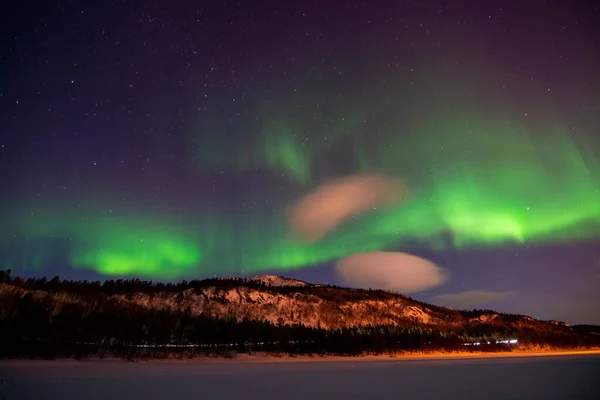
[[0, 0, 600, 324]]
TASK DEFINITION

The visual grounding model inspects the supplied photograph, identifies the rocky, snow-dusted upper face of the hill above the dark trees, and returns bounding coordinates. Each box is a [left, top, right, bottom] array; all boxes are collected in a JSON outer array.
[[0, 275, 572, 334]]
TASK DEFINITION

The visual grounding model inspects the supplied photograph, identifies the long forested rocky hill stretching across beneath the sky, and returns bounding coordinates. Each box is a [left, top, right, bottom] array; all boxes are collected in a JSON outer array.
[[0, 272, 599, 356]]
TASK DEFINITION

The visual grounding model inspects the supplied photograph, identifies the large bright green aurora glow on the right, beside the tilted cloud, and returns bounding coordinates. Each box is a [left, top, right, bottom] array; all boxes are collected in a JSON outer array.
[[360, 114, 600, 247]]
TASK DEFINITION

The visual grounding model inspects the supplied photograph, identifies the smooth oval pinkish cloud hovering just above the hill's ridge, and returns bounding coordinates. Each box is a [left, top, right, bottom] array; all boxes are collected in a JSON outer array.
[[335, 252, 447, 293]]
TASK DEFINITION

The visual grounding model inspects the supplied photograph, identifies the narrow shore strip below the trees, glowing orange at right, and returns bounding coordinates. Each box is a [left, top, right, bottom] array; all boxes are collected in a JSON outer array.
[[0, 349, 600, 367]]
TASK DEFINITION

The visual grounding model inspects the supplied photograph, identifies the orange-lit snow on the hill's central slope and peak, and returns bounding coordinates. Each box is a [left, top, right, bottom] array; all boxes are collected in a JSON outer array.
[[108, 282, 454, 328]]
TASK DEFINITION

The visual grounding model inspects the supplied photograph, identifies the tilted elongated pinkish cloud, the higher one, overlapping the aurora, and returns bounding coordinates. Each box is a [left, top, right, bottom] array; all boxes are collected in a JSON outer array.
[[288, 174, 407, 242]]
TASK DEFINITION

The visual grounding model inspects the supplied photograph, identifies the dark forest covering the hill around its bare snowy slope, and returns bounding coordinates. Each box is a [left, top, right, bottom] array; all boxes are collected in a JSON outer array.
[[0, 271, 600, 360]]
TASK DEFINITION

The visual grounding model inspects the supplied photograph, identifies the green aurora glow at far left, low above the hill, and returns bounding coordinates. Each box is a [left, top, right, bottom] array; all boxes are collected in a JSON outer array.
[[4, 212, 202, 278]]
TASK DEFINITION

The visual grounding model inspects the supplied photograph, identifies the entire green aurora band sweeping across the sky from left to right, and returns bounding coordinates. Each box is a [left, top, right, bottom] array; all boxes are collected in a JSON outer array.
[[0, 113, 600, 278]]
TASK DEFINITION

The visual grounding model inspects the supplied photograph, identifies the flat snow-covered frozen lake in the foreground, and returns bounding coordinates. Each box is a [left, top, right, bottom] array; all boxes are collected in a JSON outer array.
[[0, 355, 600, 400]]
